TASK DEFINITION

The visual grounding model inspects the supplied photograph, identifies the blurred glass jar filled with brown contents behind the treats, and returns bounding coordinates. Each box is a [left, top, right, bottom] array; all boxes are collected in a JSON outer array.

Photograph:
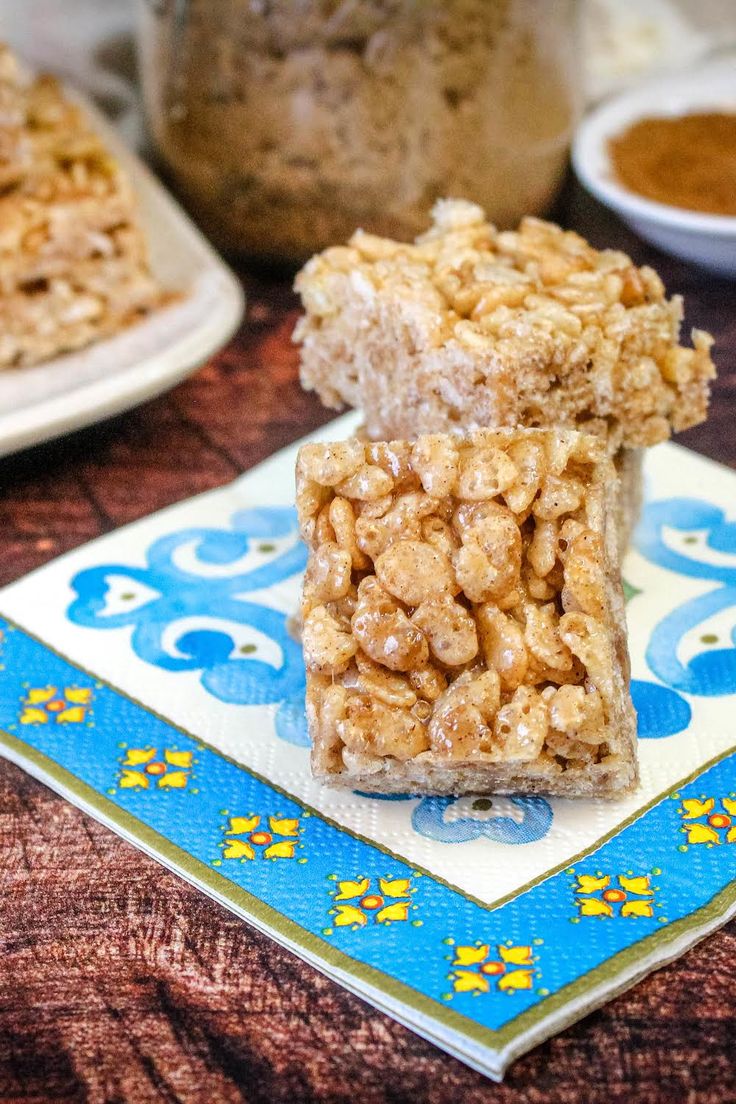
[[139, 0, 579, 262]]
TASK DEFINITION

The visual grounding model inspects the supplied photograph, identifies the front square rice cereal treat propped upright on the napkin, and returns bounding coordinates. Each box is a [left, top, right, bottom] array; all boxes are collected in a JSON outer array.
[[297, 429, 637, 797]]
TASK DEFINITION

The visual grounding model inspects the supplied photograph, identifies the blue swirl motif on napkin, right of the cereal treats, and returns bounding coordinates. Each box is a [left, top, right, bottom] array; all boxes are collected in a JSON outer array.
[[637, 498, 736, 697]]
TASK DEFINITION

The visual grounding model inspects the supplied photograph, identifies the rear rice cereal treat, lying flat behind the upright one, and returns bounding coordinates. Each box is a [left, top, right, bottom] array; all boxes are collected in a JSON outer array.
[[295, 200, 715, 455]]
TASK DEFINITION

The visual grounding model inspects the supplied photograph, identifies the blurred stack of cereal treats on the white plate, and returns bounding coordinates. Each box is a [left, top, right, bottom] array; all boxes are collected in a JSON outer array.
[[0, 46, 161, 368]]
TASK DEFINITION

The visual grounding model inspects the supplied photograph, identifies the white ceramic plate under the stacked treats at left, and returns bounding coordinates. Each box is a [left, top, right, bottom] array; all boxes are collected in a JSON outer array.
[[0, 89, 244, 456]]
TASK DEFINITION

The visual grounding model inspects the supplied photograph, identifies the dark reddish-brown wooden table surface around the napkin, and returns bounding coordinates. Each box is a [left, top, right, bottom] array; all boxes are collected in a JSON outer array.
[[0, 189, 736, 1104]]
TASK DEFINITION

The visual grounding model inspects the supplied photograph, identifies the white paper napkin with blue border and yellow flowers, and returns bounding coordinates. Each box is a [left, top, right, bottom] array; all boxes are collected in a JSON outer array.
[[0, 416, 736, 1078]]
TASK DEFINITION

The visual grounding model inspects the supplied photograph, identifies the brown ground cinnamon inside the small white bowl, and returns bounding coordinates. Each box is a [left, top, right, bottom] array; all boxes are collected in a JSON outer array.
[[609, 112, 736, 215]]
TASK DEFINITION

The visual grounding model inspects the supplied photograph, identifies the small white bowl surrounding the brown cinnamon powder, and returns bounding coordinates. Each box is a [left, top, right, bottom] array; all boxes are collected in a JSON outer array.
[[573, 59, 736, 276]]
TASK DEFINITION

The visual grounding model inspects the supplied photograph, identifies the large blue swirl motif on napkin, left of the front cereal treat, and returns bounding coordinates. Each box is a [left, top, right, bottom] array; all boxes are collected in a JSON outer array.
[[67, 507, 308, 745]]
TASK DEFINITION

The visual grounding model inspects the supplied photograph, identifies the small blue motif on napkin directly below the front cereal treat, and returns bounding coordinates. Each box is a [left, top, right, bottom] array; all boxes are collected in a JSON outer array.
[[412, 797, 552, 843]]
